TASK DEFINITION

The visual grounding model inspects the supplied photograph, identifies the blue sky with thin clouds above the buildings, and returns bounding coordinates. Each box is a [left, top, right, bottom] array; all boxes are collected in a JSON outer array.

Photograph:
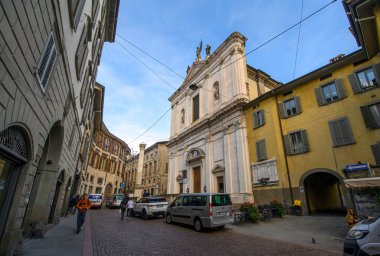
[[97, 0, 358, 151]]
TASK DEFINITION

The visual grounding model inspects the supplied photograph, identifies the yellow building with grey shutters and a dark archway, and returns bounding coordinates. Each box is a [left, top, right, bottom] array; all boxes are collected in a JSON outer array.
[[246, 1, 380, 214]]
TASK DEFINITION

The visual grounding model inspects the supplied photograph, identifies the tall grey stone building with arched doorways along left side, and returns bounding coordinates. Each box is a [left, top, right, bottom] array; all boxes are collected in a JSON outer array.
[[0, 0, 119, 252]]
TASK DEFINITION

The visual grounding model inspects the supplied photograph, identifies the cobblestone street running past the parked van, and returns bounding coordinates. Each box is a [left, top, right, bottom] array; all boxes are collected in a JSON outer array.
[[89, 209, 340, 256]]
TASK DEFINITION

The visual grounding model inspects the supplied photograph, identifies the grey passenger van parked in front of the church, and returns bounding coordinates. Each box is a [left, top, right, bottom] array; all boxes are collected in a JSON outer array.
[[165, 193, 233, 231]]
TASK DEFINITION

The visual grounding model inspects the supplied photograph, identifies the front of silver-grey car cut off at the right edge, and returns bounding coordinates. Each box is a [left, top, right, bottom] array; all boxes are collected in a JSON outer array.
[[344, 215, 380, 256]]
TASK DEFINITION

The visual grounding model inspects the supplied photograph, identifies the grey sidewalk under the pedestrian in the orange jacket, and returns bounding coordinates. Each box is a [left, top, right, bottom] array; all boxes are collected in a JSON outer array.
[[23, 212, 92, 256]]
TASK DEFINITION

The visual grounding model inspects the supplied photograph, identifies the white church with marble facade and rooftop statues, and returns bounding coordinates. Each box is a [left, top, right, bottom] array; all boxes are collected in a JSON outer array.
[[167, 32, 277, 203]]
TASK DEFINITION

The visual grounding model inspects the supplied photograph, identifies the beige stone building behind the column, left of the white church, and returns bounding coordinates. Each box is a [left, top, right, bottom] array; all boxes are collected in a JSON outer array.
[[126, 141, 168, 198]]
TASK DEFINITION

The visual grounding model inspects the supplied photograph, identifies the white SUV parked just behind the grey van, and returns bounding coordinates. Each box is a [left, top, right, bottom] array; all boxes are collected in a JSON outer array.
[[133, 197, 168, 220]]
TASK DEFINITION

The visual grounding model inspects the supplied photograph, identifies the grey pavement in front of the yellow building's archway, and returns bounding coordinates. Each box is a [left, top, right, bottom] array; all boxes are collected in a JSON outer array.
[[229, 215, 349, 254]]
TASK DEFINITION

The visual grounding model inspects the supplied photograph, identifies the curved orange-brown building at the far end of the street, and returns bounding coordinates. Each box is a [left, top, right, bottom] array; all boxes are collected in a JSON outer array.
[[85, 119, 130, 203]]
